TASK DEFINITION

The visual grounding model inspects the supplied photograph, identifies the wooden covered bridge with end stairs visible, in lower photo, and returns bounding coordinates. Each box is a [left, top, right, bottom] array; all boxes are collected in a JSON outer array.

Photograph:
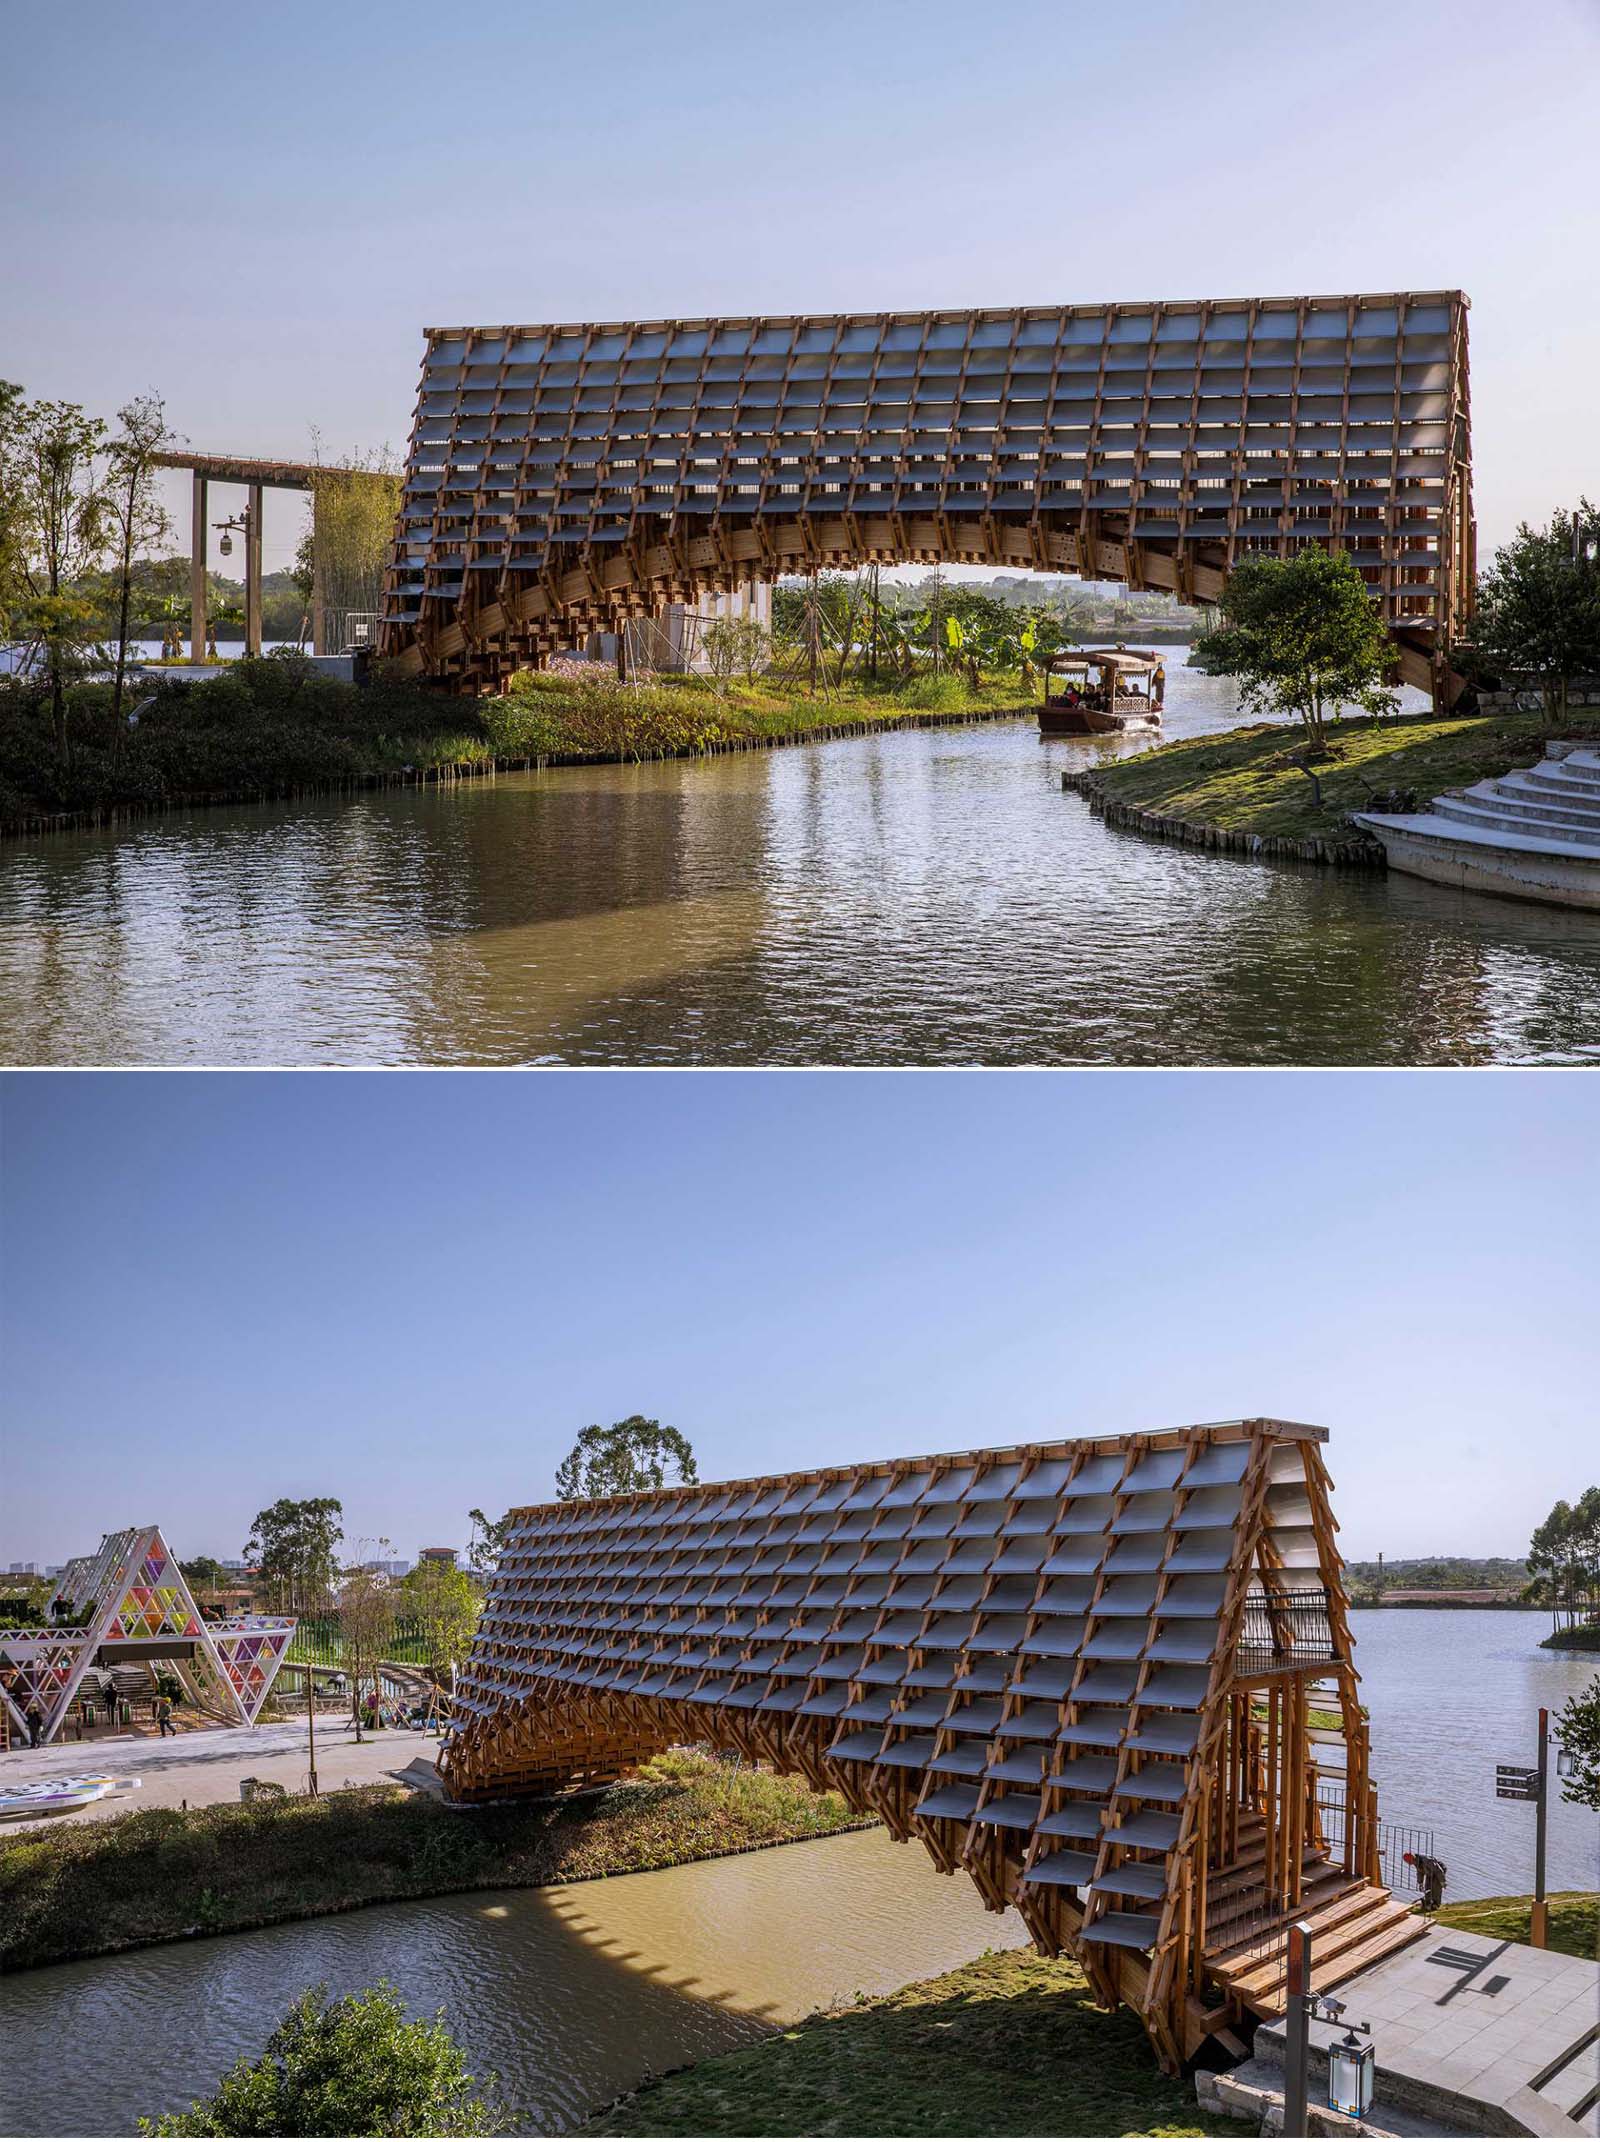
[[439, 1420, 1424, 2069]]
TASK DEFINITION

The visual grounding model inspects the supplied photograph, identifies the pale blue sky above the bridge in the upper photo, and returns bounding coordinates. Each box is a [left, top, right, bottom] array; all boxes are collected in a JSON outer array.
[[0, 0, 1600, 563]]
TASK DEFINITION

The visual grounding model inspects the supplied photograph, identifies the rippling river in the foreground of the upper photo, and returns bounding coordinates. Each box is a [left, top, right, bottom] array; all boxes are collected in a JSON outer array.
[[0, 662, 1600, 1065]]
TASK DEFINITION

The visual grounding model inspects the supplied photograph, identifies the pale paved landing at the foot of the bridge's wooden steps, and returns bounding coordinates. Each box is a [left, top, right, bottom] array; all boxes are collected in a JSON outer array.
[[1255, 1926, 1600, 2136]]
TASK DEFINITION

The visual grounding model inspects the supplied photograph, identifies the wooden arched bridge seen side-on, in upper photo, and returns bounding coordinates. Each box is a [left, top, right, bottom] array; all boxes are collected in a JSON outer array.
[[381, 291, 1474, 698]]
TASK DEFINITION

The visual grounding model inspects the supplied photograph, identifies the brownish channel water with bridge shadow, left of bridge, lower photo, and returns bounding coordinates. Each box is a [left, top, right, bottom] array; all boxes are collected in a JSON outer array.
[[0, 1831, 1022, 2136]]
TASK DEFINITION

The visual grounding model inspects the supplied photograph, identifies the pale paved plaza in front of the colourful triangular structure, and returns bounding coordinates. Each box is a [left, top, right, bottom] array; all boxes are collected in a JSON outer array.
[[0, 1718, 439, 1838]]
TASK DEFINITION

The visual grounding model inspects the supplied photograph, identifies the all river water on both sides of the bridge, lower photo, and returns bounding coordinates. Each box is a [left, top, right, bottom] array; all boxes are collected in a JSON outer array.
[[0, 1609, 1596, 2136]]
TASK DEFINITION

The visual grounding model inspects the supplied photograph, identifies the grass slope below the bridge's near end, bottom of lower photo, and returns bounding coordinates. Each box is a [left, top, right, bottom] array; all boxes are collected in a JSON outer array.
[[585, 1949, 1255, 2136]]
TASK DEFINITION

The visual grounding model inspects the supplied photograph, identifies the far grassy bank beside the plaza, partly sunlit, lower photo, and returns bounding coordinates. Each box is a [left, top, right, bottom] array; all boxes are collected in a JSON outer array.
[[0, 1754, 869, 1971]]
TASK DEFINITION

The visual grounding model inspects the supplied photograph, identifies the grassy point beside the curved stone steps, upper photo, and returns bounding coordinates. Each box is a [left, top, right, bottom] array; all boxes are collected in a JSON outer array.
[[1095, 713, 1600, 840]]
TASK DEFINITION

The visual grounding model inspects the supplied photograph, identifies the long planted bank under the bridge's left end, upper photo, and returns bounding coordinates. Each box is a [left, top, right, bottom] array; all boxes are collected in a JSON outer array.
[[0, 658, 1028, 833]]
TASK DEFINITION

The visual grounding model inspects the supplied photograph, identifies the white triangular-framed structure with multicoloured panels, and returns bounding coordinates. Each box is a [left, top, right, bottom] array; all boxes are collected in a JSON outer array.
[[0, 1525, 296, 1746]]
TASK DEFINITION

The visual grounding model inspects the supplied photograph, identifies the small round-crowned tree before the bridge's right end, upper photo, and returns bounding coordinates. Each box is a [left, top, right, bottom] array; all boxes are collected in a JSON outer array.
[[1195, 550, 1399, 756]]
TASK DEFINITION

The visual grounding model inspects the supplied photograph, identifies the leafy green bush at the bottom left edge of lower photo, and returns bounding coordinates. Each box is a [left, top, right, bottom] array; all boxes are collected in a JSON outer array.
[[139, 1983, 505, 2136]]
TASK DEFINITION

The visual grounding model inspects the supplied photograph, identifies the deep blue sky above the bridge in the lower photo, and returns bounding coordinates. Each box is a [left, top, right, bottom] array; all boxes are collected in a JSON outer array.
[[0, 1071, 1600, 1562]]
